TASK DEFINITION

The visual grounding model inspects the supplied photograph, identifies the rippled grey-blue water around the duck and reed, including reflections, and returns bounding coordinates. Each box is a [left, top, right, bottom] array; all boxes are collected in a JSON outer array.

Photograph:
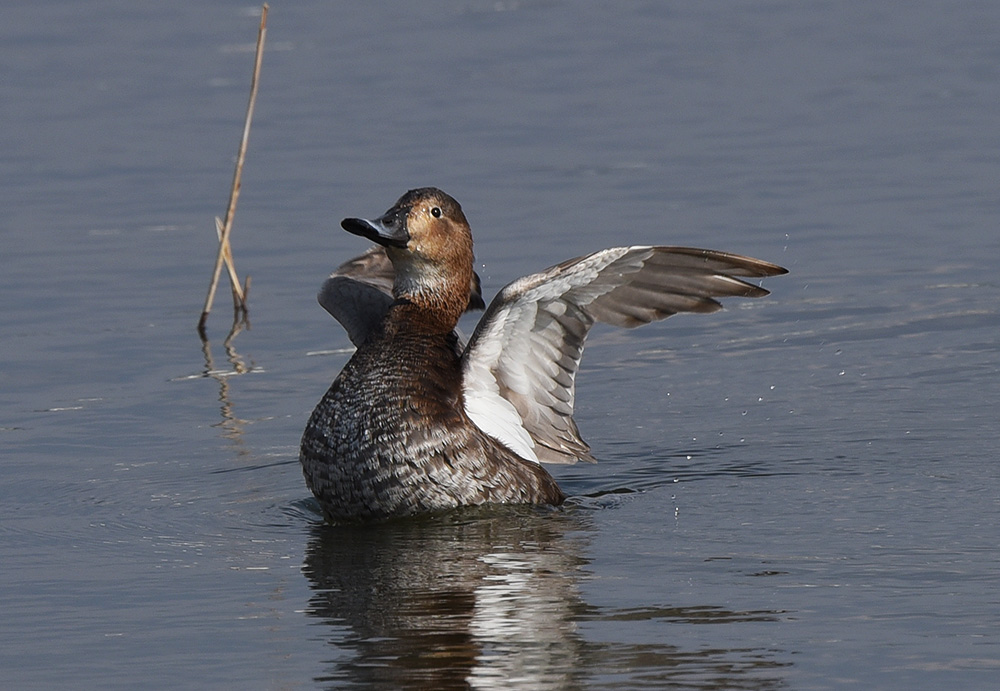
[[0, 0, 1000, 689]]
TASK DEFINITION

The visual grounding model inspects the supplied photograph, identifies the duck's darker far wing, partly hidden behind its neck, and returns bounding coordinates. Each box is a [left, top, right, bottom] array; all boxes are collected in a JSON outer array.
[[316, 245, 486, 346]]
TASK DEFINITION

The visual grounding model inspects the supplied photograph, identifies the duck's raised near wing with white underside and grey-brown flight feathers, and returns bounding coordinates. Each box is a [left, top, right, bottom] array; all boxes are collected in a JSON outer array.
[[462, 247, 787, 463]]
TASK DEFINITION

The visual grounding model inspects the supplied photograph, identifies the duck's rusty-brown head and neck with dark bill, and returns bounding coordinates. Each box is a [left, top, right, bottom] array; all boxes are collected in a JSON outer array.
[[341, 187, 483, 328]]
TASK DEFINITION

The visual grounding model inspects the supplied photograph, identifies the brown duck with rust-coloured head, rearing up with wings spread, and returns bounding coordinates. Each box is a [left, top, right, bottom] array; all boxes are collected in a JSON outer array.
[[299, 187, 787, 523]]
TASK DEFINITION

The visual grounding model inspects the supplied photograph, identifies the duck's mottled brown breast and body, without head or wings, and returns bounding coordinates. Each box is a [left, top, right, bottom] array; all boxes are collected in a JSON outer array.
[[300, 308, 563, 521]]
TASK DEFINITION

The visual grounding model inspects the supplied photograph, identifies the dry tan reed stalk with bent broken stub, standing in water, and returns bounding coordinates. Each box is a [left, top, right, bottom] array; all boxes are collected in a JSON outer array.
[[198, 3, 268, 339]]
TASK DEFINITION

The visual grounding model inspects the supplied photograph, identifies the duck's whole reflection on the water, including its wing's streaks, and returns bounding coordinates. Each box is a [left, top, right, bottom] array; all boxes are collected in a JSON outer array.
[[304, 507, 786, 690]]
